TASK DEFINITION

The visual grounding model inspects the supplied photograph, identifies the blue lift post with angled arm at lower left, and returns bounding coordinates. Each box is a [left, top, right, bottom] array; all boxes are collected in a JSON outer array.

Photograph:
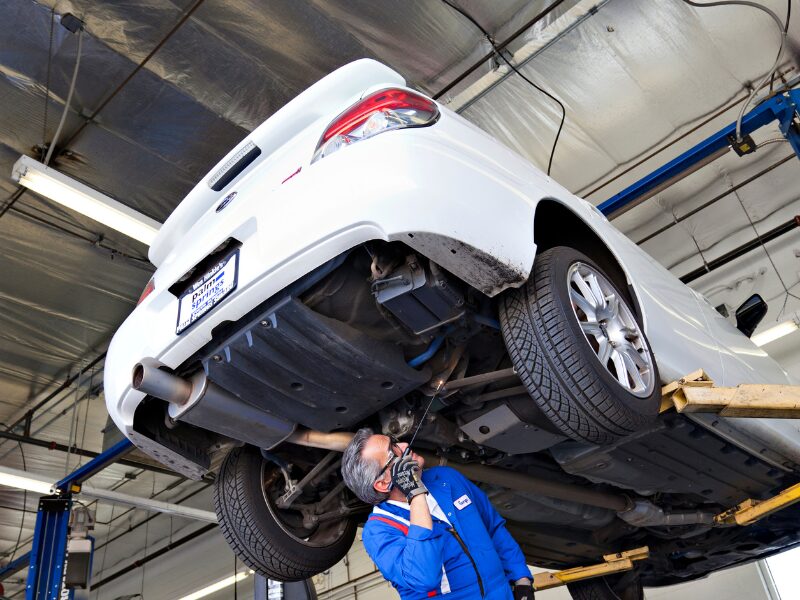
[[25, 439, 133, 600]]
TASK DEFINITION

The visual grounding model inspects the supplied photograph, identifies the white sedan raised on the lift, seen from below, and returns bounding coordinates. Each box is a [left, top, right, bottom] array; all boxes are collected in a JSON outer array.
[[105, 60, 800, 598]]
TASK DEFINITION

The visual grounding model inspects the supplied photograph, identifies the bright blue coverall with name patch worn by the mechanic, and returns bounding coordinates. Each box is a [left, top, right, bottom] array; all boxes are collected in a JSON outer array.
[[363, 467, 532, 600]]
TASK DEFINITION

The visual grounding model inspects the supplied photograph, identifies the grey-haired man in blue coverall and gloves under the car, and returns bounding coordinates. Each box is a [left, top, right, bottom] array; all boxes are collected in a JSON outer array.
[[342, 428, 533, 600]]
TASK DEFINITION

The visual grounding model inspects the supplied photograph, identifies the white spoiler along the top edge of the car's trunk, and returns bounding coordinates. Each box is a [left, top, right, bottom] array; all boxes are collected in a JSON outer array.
[[148, 59, 406, 267]]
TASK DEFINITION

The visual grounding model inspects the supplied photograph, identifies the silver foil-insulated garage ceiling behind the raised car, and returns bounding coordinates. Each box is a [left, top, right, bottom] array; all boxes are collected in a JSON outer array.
[[0, 0, 800, 597]]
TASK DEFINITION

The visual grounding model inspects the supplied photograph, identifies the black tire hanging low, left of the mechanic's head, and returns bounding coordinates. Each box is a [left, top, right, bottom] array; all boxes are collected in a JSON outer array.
[[214, 447, 356, 581]]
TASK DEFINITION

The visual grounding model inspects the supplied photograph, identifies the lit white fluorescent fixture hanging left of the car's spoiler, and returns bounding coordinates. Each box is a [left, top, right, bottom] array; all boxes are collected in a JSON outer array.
[[11, 156, 161, 246]]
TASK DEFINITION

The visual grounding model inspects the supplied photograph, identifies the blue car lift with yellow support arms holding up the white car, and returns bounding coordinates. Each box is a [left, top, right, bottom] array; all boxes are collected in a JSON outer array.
[[0, 82, 800, 600]]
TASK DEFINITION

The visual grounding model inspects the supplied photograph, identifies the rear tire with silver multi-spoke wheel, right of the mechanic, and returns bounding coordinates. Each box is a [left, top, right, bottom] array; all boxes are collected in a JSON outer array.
[[499, 246, 661, 444]]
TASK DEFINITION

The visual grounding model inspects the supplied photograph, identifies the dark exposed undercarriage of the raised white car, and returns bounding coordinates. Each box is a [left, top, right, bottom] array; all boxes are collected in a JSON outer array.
[[126, 242, 800, 586]]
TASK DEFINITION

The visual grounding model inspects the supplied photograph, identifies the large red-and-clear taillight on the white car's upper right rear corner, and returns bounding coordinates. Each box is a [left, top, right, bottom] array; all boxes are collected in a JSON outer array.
[[311, 88, 439, 162]]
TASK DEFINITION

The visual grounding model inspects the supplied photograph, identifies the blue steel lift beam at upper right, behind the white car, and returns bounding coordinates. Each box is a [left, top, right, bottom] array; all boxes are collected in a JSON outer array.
[[597, 89, 800, 218]]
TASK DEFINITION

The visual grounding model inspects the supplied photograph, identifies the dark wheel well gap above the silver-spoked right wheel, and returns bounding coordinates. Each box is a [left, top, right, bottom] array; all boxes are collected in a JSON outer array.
[[533, 200, 642, 320]]
